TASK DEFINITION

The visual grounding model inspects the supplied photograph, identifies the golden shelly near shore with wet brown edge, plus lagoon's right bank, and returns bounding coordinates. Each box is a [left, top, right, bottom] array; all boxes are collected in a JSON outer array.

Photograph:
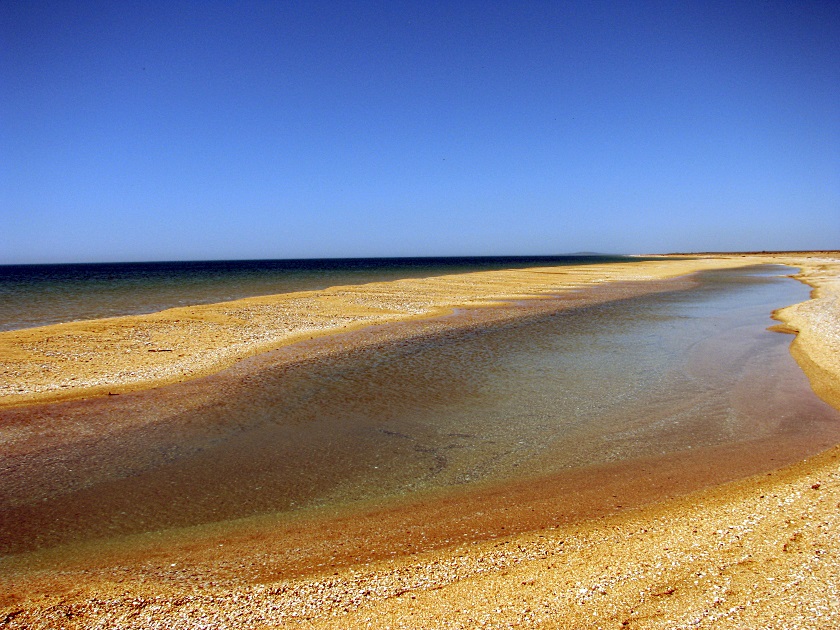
[[0, 256, 840, 627]]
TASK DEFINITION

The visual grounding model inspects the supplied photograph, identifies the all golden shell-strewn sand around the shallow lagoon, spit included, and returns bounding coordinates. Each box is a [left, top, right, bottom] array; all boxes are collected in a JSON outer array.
[[0, 252, 840, 628]]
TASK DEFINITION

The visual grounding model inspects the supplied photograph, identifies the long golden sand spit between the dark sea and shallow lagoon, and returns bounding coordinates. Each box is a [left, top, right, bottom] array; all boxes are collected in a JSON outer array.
[[0, 256, 768, 407]]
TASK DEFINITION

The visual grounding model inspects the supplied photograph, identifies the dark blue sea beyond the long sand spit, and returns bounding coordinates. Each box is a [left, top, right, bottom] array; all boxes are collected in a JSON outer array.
[[0, 255, 641, 330]]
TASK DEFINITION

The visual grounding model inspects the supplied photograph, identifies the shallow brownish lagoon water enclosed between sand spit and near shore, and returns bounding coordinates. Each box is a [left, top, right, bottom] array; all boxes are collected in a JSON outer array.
[[0, 266, 840, 551]]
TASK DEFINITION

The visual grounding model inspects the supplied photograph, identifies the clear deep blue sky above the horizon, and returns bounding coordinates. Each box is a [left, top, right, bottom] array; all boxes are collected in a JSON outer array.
[[0, 0, 840, 263]]
